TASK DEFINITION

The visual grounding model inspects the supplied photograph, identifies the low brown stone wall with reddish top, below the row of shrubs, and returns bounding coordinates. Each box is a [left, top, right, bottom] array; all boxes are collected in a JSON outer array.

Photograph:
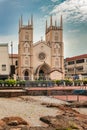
[[0, 87, 85, 97]]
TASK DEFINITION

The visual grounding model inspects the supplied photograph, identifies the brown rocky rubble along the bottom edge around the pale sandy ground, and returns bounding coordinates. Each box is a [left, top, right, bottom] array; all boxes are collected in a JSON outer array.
[[0, 102, 87, 130]]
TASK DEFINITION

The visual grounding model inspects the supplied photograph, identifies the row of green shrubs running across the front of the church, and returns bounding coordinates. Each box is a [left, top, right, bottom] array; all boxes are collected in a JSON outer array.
[[0, 79, 87, 87]]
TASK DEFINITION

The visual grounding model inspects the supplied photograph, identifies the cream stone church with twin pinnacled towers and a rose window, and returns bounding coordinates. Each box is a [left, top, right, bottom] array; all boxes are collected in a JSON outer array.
[[17, 16, 64, 80]]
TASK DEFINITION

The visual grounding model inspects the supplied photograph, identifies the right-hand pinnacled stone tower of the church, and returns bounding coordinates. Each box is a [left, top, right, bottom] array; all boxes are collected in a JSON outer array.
[[45, 16, 64, 78]]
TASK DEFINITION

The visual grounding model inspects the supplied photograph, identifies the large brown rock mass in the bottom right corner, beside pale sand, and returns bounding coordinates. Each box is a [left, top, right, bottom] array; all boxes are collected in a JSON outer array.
[[40, 104, 87, 130]]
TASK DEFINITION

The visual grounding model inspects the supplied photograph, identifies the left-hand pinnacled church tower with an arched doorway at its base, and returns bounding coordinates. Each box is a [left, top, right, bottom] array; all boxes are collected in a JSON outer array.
[[18, 16, 33, 80]]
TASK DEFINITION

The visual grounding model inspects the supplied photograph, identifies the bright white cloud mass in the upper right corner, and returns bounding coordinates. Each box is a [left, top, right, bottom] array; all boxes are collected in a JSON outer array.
[[51, 0, 87, 23]]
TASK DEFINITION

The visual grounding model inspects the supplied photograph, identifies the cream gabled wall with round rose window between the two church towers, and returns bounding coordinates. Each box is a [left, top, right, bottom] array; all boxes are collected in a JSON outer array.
[[33, 42, 51, 68]]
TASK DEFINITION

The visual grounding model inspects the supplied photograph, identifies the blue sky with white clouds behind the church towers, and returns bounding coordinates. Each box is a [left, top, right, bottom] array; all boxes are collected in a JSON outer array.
[[0, 0, 87, 58]]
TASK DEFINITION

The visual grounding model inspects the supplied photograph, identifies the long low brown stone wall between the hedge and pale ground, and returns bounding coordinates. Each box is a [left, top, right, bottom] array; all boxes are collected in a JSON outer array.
[[0, 88, 73, 97]]
